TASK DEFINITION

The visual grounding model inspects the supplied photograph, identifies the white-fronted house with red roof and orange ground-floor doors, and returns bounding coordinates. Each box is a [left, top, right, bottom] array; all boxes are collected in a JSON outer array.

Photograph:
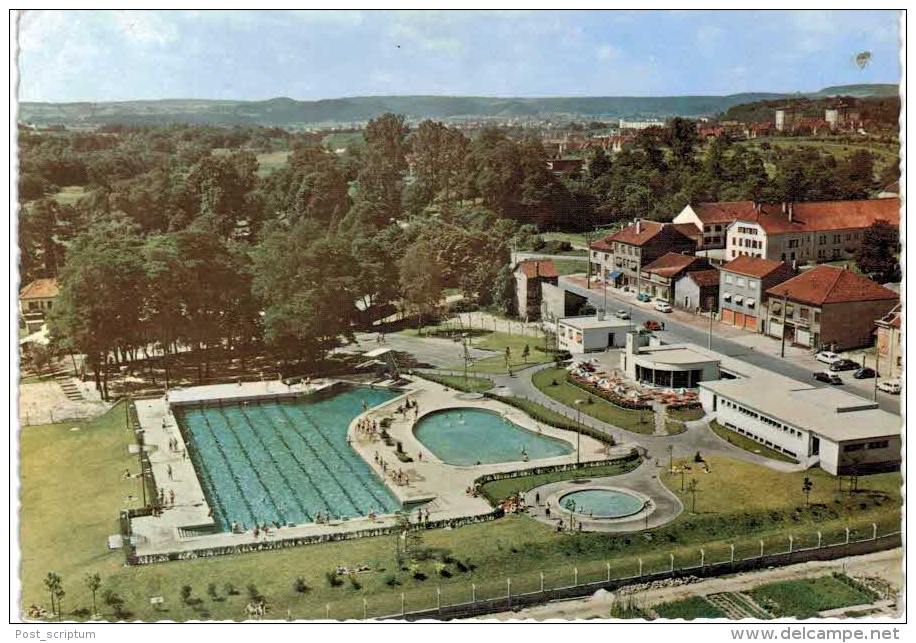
[[719, 255, 795, 333]]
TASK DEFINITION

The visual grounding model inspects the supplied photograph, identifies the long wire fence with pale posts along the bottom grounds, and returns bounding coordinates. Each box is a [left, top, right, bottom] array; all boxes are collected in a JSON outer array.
[[289, 523, 902, 621]]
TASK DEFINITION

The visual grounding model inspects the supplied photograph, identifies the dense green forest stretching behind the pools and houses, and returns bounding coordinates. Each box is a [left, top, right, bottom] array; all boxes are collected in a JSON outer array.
[[19, 114, 896, 398]]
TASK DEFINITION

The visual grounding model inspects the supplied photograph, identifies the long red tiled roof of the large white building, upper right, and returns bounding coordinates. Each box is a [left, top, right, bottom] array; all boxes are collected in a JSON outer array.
[[737, 197, 900, 234]]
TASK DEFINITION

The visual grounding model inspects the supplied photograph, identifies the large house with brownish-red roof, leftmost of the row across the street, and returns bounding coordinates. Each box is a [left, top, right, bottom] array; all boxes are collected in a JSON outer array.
[[589, 219, 697, 288]]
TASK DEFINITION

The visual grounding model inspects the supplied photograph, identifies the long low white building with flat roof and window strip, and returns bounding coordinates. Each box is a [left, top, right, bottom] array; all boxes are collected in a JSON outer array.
[[699, 372, 901, 475]]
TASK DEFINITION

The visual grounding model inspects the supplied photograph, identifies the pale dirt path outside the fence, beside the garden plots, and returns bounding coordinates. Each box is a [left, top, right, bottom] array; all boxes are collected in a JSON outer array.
[[493, 549, 904, 621]]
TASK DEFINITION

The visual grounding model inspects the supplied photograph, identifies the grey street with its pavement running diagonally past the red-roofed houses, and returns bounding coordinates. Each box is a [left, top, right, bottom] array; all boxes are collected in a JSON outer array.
[[560, 277, 900, 415]]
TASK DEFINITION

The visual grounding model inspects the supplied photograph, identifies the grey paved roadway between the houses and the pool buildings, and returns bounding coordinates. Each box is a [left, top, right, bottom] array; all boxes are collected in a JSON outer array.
[[561, 279, 900, 415]]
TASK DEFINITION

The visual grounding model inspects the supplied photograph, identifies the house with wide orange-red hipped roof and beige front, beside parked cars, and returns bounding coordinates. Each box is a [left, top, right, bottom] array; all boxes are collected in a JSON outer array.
[[766, 265, 899, 350]]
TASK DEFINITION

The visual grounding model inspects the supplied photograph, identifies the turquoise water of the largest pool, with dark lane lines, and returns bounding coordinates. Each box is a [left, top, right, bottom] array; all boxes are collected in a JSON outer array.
[[176, 388, 401, 531]]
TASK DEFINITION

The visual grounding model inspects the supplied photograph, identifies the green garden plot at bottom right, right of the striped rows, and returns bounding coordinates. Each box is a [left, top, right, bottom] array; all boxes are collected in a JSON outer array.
[[748, 576, 876, 618]]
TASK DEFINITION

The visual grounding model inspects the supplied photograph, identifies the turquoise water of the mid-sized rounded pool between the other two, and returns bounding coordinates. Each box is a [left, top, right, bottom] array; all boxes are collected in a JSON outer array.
[[414, 408, 572, 465]]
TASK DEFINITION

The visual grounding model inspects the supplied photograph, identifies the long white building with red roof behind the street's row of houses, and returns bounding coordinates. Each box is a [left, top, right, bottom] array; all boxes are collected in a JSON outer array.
[[725, 198, 900, 264]]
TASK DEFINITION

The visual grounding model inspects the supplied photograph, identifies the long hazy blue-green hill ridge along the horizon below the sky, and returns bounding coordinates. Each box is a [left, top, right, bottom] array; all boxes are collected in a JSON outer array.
[[19, 85, 896, 127]]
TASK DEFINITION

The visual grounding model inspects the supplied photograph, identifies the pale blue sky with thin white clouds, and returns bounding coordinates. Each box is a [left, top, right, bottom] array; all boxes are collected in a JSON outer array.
[[18, 10, 900, 102]]
